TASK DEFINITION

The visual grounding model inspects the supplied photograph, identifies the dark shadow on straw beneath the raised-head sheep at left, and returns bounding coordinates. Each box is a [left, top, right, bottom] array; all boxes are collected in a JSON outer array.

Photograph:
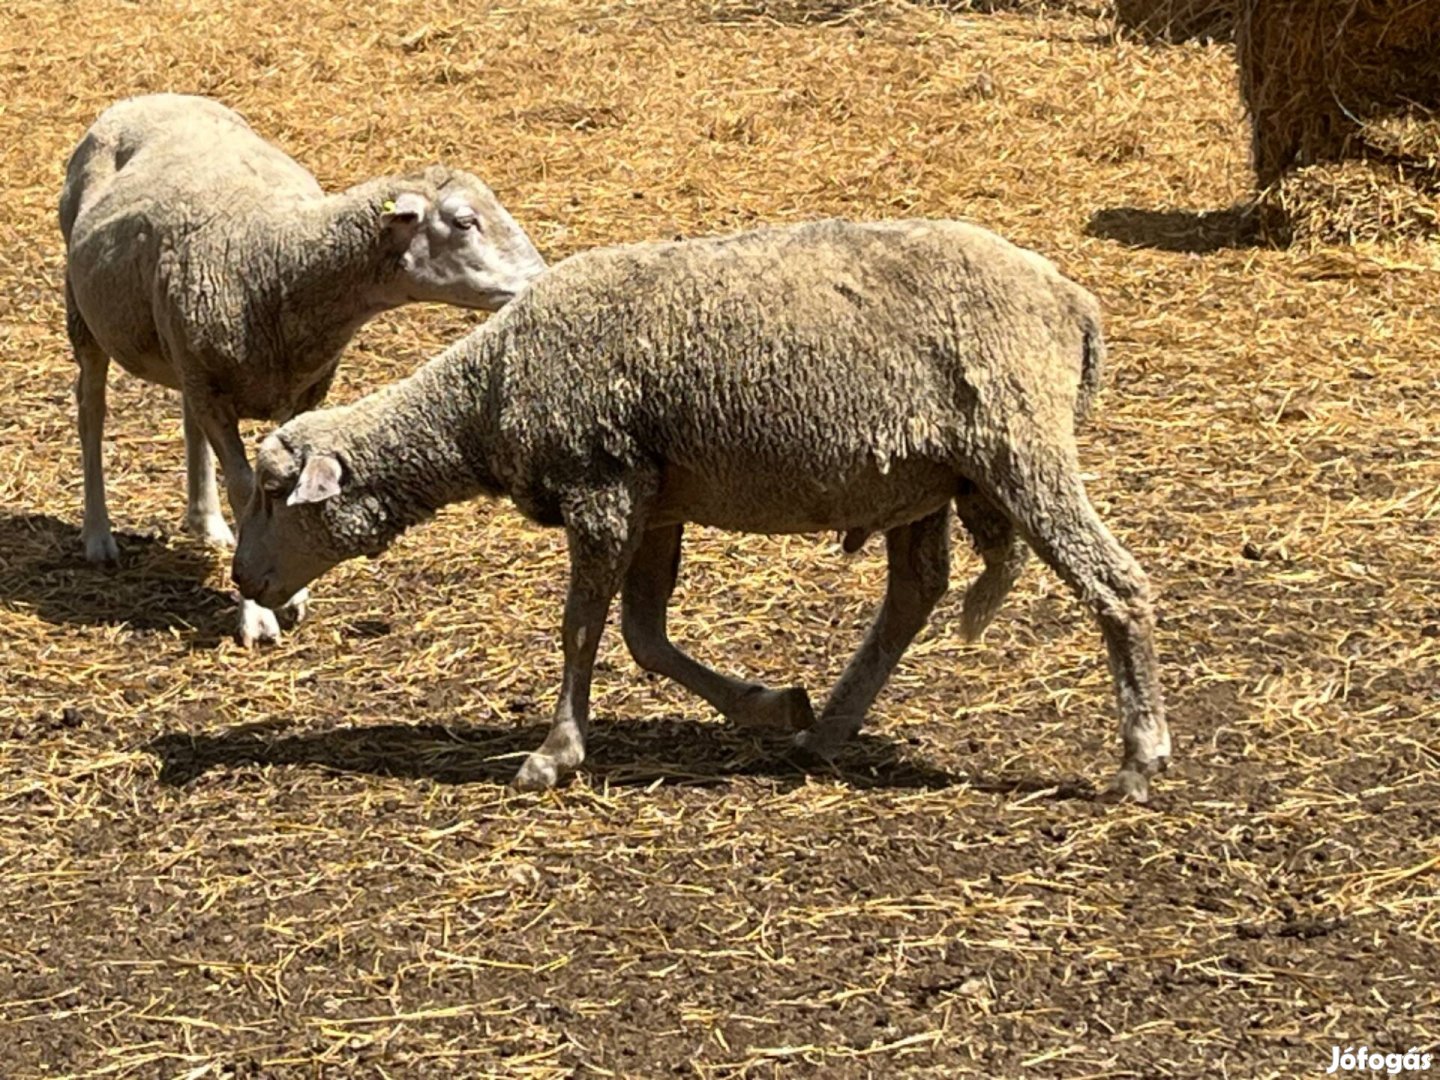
[[0, 511, 235, 645]]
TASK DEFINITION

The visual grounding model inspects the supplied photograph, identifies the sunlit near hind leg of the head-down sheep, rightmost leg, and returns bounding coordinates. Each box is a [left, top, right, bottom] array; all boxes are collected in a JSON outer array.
[[992, 461, 1171, 802]]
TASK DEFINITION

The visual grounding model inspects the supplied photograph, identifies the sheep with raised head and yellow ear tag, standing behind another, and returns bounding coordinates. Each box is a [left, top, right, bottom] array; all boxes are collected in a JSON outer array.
[[59, 94, 544, 645]]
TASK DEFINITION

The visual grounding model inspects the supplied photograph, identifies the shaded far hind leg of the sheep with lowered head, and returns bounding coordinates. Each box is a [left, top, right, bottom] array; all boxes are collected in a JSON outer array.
[[795, 507, 950, 759]]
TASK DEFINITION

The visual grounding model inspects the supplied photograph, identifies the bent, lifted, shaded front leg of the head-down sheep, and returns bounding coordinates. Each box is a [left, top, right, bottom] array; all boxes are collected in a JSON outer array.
[[621, 526, 815, 730]]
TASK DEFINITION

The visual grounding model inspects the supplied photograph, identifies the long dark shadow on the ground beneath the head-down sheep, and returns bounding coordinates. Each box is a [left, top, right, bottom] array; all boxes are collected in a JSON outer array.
[[144, 719, 1094, 799]]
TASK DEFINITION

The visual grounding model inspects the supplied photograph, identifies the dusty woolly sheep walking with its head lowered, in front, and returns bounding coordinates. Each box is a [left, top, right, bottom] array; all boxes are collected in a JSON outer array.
[[232, 219, 1169, 802]]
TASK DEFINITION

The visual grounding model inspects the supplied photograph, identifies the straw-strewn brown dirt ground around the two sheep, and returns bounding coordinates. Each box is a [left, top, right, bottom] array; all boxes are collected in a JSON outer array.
[[0, 0, 1440, 1080]]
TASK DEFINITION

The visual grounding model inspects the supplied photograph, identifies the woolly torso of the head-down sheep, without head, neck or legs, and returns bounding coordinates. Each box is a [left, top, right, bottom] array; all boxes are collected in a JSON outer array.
[[471, 220, 1103, 524]]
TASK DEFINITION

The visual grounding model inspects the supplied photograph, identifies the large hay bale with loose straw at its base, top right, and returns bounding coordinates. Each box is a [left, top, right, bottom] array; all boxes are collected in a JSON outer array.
[[1237, 0, 1440, 243]]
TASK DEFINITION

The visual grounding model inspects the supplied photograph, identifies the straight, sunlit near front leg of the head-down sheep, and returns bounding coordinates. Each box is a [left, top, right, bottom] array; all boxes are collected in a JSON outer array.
[[510, 487, 644, 791]]
